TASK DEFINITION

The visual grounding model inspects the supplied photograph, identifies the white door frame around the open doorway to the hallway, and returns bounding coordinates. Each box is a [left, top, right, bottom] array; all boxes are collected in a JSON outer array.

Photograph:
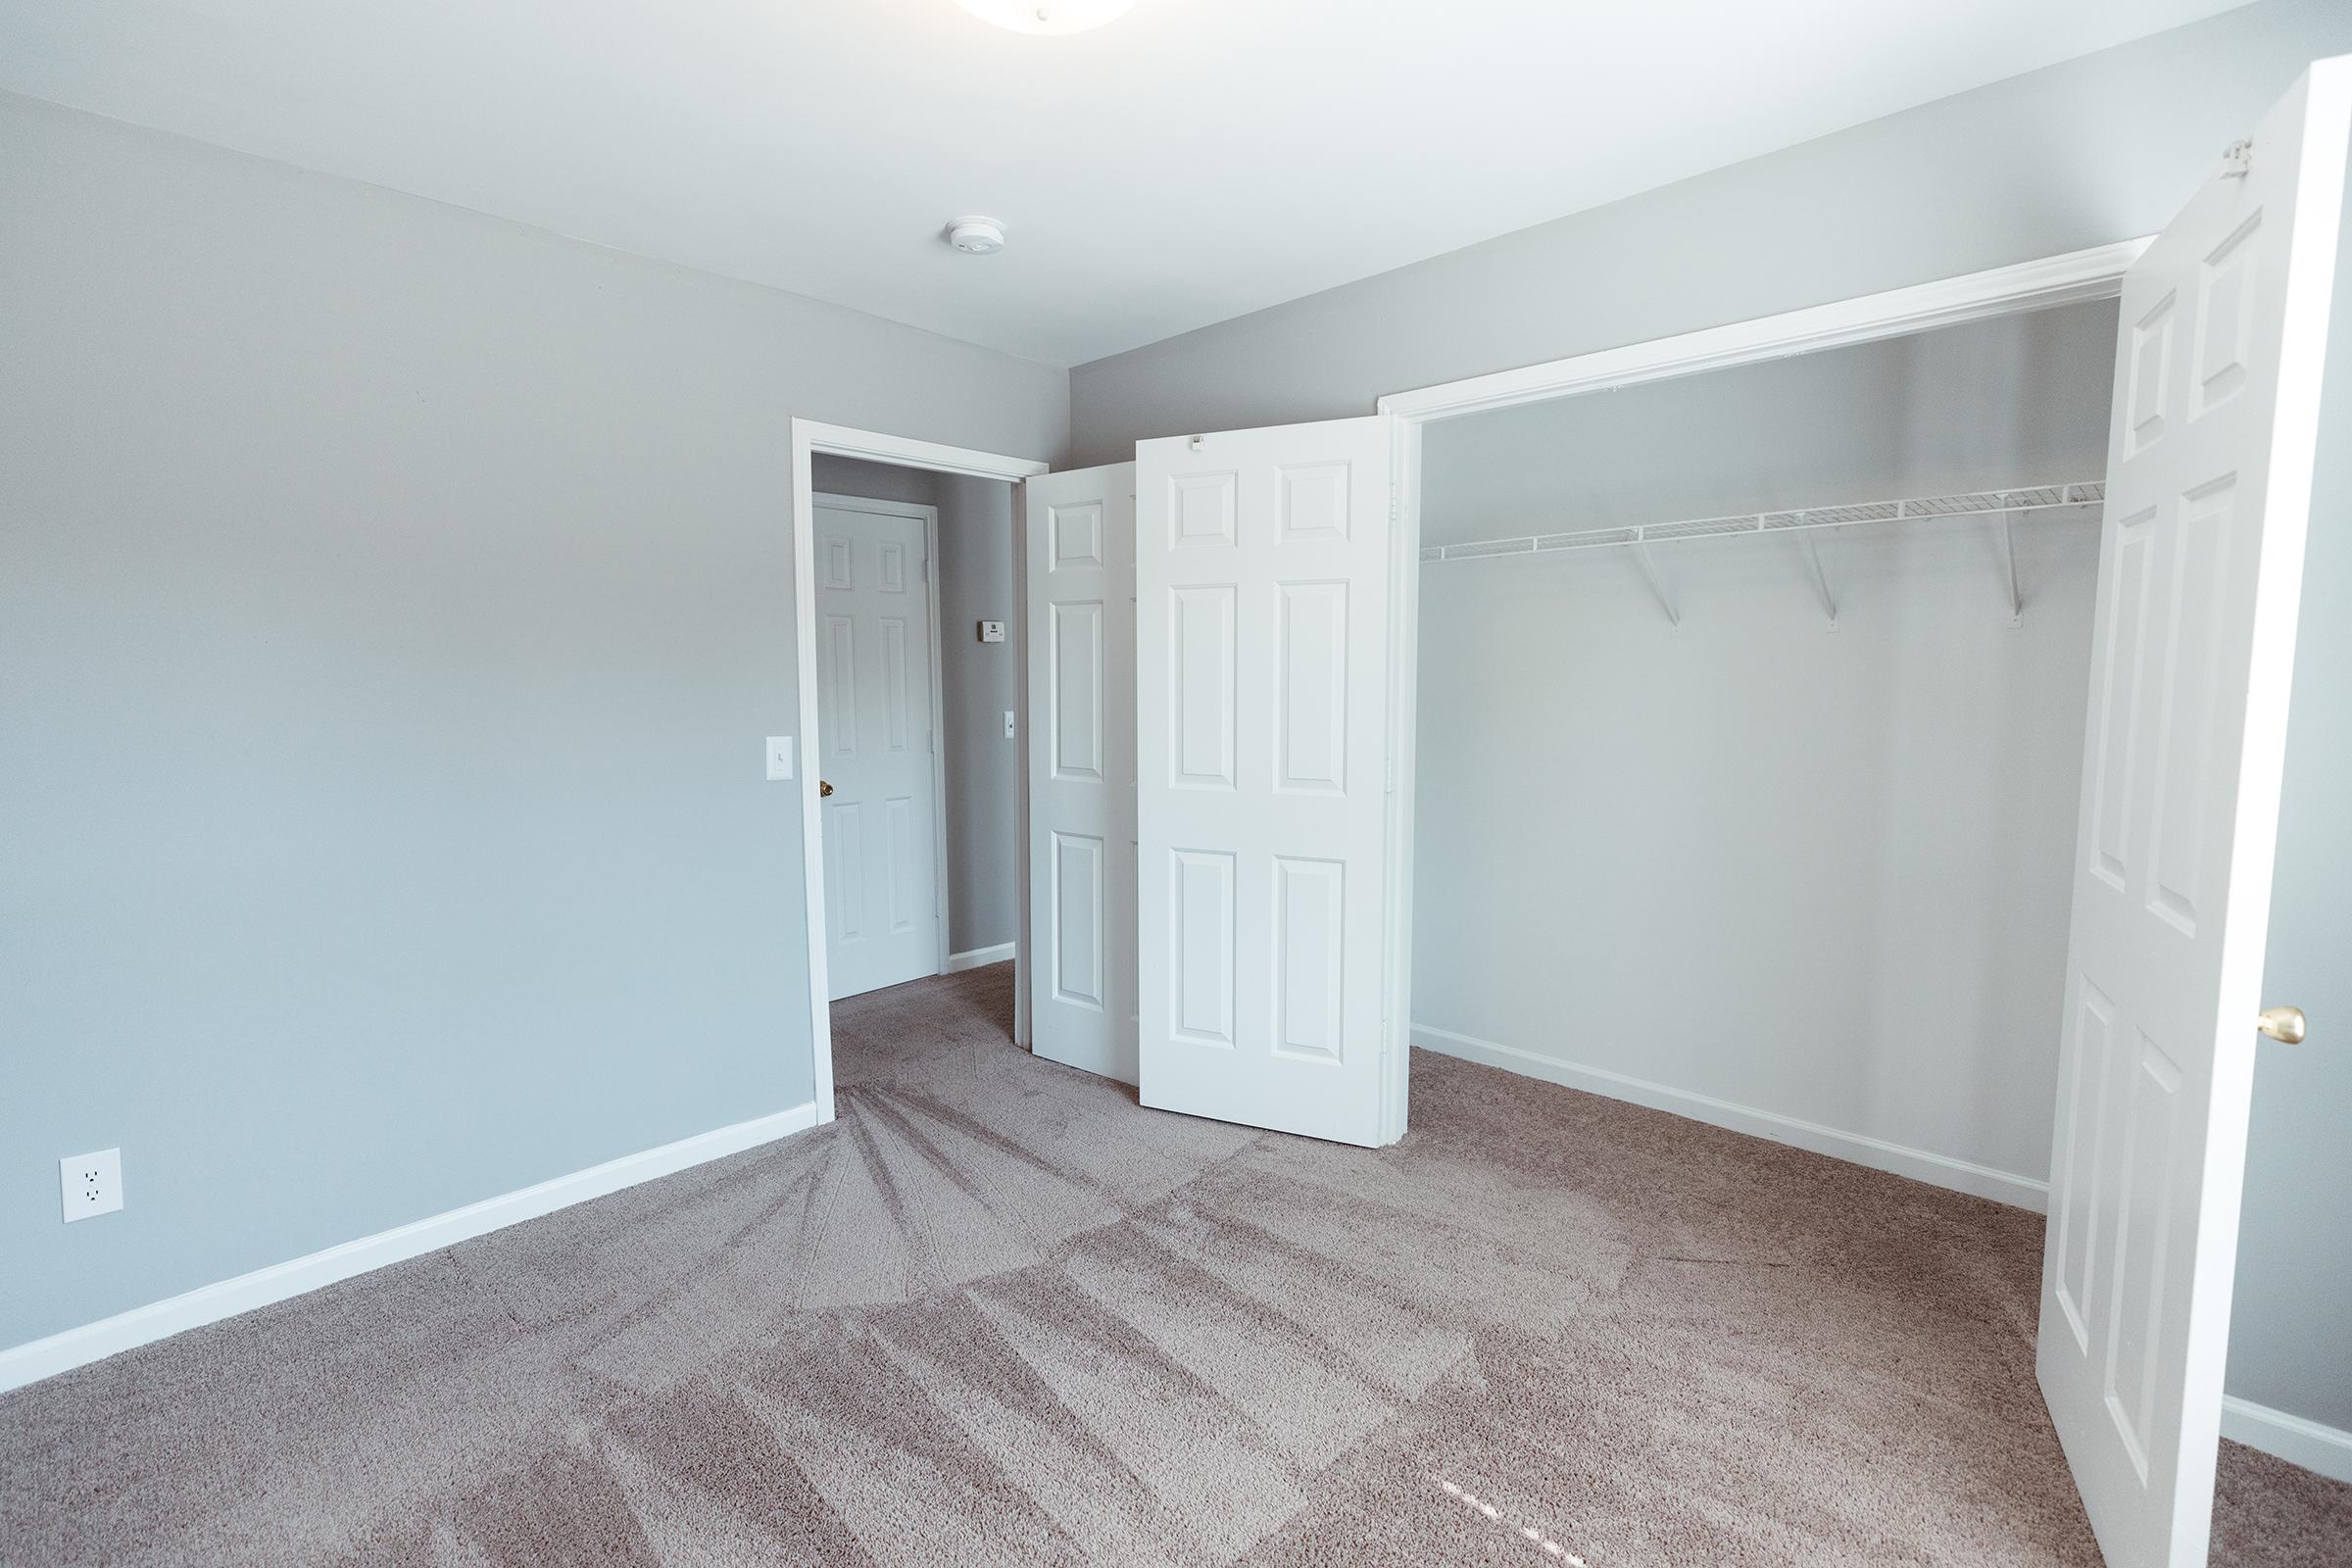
[[790, 418, 1054, 1121]]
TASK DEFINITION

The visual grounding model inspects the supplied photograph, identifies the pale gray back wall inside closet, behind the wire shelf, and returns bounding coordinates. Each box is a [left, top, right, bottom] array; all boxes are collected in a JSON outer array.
[[1413, 306, 2115, 1180]]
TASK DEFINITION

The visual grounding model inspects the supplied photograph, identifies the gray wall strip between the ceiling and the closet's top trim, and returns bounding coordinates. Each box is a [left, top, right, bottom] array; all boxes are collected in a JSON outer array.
[[1070, 0, 2352, 464]]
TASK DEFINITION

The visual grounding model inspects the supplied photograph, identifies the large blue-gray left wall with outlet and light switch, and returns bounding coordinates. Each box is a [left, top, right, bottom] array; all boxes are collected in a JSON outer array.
[[0, 96, 1068, 1345]]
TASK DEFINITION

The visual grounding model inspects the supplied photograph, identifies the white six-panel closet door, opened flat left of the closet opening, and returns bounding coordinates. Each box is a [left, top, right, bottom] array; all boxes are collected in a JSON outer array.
[[1136, 416, 1409, 1145]]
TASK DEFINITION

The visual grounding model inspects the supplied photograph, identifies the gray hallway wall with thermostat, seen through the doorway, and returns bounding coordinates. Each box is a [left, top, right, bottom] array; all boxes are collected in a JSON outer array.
[[813, 446, 1021, 953]]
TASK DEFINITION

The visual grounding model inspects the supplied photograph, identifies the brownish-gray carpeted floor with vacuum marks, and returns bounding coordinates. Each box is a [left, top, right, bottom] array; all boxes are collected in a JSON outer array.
[[0, 966, 2352, 1568]]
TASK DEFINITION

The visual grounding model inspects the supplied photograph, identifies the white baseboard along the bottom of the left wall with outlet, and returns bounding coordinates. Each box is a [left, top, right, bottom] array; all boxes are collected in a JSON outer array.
[[0, 1104, 816, 1394]]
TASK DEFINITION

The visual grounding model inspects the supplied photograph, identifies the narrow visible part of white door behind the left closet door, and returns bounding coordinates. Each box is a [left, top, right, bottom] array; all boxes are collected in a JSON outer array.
[[1021, 464, 1136, 1084]]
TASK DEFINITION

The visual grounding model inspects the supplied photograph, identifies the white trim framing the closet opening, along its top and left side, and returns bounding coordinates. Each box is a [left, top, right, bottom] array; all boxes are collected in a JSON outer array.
[[1376, 235, 2154, 1161]]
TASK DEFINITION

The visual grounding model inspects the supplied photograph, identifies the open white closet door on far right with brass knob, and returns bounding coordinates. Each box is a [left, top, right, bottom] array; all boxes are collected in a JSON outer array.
[[2036, 61, 2352, 1568]]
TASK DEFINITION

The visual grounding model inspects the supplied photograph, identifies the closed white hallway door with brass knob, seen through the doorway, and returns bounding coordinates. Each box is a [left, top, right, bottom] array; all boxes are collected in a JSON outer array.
[[807, 496, 941, 999]]
